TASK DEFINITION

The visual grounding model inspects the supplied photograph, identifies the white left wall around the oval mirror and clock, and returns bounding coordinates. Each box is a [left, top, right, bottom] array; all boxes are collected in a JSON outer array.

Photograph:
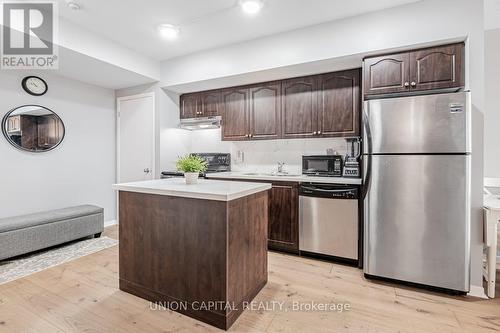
[[0, 71, 116, 221]]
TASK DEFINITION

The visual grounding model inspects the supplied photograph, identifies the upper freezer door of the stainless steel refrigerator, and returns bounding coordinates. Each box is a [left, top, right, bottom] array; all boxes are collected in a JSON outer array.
[[363, 92, 470, 154]]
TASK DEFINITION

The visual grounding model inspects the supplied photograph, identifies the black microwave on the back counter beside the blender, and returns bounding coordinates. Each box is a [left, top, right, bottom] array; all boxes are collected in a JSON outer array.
[[302, 155, 342, 177]]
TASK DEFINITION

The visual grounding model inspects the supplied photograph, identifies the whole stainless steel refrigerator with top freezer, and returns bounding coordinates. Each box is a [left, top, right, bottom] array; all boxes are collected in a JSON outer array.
[[363, 92, 471, 292]]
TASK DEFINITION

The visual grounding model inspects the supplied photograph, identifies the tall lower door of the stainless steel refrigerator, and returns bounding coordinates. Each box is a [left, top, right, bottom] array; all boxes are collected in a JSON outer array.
[[364, 155, 470, 292]]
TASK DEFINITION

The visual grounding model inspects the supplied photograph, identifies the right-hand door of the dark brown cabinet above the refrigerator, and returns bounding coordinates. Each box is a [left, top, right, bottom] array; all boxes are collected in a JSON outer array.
[[410, 44, 465, 90]]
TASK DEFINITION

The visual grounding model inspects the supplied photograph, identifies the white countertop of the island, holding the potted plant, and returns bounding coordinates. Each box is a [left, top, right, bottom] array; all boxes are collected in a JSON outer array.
[[113, 178, 271, 201]]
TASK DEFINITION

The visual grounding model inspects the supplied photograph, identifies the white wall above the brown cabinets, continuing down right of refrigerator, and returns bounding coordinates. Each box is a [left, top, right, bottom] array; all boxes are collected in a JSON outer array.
[[161, 0, 484, 291]]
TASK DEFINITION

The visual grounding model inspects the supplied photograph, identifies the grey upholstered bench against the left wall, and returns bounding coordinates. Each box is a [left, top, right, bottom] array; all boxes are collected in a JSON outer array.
[[0, 205, 104, 260]]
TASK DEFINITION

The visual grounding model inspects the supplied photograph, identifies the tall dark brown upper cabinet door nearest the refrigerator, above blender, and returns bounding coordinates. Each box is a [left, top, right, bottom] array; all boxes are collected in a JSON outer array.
[[317, 69, 361, 137]]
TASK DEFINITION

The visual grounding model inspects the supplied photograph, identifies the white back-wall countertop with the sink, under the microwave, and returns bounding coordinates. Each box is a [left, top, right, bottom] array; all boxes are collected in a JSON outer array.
[[206, 172, 362, 185]]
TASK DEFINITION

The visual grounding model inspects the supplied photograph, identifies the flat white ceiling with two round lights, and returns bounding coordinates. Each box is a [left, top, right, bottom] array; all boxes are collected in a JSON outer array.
[[59, 0, 420, 60]]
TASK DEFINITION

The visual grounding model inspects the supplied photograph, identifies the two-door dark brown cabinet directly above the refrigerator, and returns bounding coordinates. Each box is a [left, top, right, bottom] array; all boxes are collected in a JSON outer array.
[[363, 43, 465, 96]]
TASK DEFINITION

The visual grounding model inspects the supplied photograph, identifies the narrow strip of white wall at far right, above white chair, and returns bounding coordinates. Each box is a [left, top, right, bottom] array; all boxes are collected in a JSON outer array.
[[484, 29, 500, 178]]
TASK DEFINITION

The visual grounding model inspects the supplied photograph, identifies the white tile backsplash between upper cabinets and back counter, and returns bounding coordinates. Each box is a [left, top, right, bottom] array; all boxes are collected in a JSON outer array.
[[191, 129, 347, 173]]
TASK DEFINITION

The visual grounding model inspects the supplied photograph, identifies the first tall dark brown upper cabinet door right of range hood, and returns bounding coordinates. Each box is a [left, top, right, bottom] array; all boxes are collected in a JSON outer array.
[[221, 87, 250, 141]]
